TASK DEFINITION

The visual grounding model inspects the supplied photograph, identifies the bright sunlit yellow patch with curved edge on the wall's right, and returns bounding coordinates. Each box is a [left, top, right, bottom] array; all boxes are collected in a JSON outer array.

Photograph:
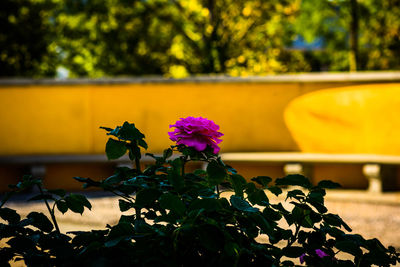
[[285, 83, 400, 155]]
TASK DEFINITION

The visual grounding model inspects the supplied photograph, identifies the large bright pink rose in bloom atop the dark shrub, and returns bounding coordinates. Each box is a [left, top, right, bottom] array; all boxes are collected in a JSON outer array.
[[168, 117, 223, 154]]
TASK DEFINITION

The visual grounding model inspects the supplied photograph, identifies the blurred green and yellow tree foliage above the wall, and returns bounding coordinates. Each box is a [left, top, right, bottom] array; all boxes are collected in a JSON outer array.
[[0, 0, 400, 78]]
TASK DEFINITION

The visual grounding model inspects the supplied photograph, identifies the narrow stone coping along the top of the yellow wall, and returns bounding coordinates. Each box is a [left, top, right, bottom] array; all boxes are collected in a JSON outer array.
[[0, 71, 400, 86]]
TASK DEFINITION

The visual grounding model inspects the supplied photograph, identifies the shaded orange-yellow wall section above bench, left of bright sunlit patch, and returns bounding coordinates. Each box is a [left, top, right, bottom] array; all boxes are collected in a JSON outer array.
[[0, 82, 358, 155]]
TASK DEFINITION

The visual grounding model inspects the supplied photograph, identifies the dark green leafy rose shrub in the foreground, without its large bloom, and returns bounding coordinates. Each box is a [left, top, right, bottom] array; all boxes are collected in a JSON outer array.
[[0, 122, 400, 266]]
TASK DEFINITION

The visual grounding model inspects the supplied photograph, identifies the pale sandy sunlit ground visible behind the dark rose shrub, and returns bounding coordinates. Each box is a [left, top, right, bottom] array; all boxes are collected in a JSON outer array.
[[2, 190, 400, 266]]
